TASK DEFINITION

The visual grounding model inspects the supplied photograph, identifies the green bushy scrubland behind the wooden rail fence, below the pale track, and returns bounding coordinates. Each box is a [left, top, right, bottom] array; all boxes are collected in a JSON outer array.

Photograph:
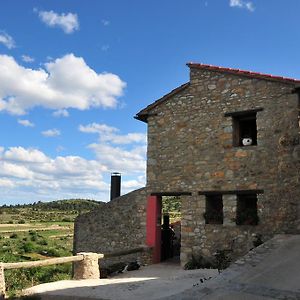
[[0, 228, 73, 295]]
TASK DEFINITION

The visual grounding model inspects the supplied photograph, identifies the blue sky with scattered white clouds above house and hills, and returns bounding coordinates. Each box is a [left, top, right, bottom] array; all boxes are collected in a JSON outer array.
[[0, 0, 300, 204]]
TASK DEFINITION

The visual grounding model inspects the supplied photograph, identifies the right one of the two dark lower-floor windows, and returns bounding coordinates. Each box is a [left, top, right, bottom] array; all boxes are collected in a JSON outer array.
[[236, 194, 258, 225]]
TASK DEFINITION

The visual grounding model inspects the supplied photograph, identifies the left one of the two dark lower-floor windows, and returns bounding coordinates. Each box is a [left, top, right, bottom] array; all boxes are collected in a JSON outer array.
[[204, 194, 223, 224]]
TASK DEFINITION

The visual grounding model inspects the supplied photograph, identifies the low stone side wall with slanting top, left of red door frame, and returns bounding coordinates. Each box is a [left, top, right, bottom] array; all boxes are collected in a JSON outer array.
[[74, 189, 146, 267]]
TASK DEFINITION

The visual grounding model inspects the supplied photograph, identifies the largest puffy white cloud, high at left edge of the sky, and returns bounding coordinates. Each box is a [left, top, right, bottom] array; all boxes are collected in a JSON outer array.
[[0, 54, 126, 115]]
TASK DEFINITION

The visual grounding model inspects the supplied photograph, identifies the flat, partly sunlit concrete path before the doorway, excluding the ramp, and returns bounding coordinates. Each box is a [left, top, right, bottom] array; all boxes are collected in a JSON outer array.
[[26, 263, 218, 300]]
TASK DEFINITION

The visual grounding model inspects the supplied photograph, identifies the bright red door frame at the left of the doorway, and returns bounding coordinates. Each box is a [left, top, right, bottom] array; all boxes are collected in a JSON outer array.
[[146, 196, 161, 263]]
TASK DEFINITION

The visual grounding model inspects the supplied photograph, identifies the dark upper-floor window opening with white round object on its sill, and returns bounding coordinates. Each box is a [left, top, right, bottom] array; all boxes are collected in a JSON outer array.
[[232, 112, 257, 147]]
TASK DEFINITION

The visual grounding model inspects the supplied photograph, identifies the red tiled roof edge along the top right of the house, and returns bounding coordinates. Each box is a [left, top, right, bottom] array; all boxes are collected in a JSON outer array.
[[187, 62, 300, 83]]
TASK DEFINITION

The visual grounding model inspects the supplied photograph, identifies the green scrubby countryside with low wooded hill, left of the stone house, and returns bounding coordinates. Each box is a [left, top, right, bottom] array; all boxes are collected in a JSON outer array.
[[0, 200, 101, 297]]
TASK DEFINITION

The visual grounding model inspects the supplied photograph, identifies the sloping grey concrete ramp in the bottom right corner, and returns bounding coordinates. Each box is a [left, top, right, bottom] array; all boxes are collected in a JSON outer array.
[[165, 235, 300, 300]]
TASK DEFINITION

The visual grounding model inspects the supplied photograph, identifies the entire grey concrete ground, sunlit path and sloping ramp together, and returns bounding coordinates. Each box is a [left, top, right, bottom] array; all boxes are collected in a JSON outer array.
[[24, 235, 300, 300]]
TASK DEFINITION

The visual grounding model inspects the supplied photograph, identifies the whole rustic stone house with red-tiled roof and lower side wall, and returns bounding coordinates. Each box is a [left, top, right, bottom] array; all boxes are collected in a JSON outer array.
[[74, 63, 300, 264]]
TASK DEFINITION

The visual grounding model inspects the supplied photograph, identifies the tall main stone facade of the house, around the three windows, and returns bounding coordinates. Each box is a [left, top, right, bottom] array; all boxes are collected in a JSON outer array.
[[147, 68, 300, 262]]
